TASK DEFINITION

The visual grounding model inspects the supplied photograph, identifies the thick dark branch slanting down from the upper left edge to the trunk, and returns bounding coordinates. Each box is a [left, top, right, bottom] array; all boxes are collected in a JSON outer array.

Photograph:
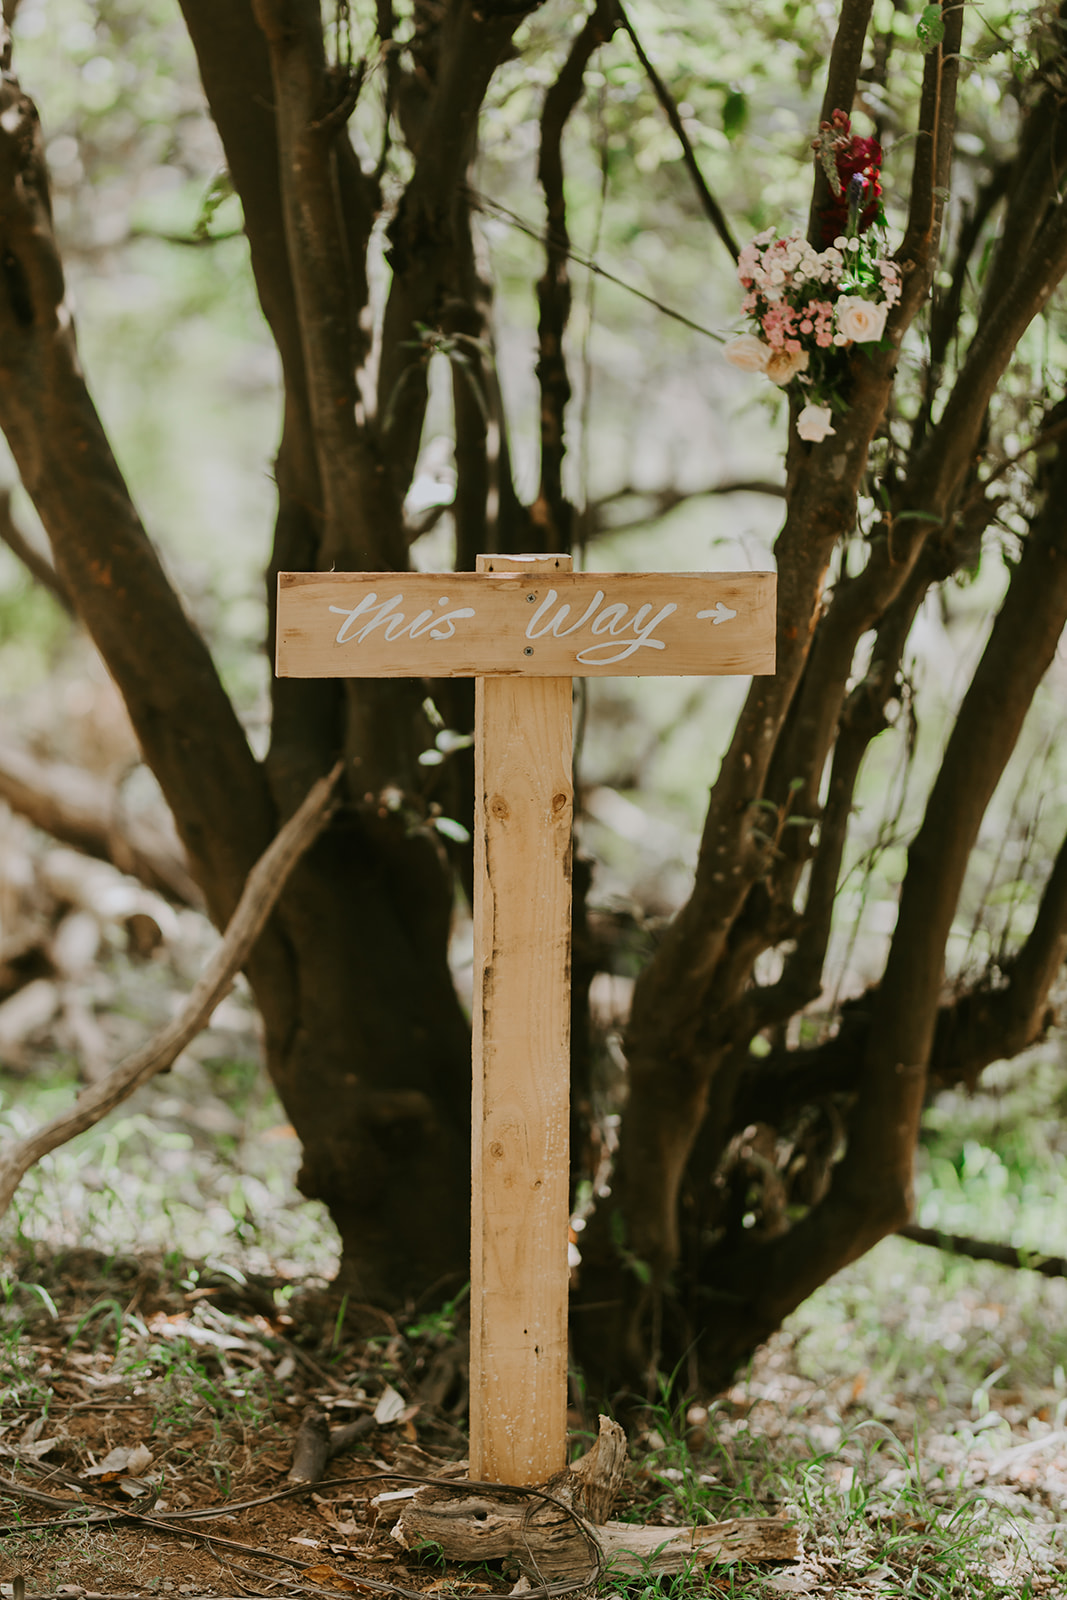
[[0, 56, 274, 922]]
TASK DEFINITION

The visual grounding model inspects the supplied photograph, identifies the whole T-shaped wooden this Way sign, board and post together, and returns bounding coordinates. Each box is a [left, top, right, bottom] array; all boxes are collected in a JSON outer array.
[[277, 555, 774, 1485]]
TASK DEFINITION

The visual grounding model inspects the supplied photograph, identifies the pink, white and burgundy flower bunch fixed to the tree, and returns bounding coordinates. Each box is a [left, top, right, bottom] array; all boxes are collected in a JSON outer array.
[[723, 110, 901, 443]]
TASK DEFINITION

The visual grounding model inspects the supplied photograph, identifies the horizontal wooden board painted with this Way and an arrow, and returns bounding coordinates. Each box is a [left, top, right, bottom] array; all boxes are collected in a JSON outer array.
[[277, 562, 776, 678]]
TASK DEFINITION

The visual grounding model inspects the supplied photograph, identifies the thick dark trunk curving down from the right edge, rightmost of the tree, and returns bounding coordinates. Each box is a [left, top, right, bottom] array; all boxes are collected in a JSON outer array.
[[720, 428, 1067, 1350]]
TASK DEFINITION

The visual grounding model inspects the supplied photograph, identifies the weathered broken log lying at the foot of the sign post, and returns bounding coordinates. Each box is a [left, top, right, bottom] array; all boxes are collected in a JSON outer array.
[[397, 1418, 800, 1582]]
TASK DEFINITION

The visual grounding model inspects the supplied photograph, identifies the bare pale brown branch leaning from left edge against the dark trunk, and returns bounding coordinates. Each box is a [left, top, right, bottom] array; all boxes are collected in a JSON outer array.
[[0, 763, 342, 1216]]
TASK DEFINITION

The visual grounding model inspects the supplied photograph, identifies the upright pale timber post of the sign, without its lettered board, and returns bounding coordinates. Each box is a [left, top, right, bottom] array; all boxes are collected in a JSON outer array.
[[470, 555, 573, 1483]]
